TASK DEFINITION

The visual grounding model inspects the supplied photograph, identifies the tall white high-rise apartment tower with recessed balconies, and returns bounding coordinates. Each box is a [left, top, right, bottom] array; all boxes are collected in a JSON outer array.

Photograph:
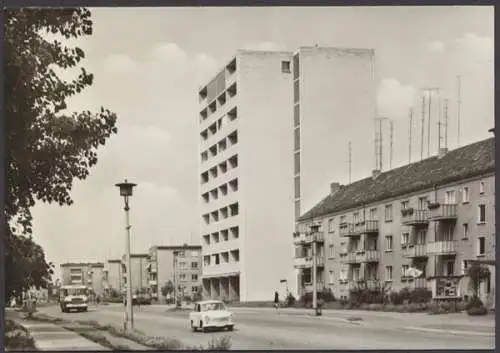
[[198, 47, 375, 301]]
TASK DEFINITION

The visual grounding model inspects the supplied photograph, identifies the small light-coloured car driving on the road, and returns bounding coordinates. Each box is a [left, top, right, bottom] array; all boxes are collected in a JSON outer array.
[[189, 300, 234, 332]]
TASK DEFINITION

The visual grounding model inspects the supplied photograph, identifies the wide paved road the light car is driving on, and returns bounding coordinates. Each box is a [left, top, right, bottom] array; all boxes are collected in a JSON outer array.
[[40, 305, 495, 349]]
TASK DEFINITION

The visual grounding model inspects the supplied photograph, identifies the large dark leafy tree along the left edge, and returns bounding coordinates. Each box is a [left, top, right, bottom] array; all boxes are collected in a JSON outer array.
[[4, 8, 117, 297]]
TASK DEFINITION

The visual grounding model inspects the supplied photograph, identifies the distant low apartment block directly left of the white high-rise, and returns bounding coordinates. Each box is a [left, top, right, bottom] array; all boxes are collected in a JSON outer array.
[[147, 244, 202, 300]]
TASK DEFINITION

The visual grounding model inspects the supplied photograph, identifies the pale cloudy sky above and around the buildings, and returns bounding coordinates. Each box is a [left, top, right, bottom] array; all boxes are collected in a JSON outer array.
[[29, 6, 494, 280]]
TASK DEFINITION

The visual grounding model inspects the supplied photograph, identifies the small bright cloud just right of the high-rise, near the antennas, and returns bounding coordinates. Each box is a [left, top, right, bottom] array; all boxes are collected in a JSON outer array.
[[377, 78, 417, 119]]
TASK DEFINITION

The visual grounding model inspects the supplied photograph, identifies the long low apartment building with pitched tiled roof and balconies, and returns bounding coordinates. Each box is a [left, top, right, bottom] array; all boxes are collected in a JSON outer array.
[[294, 138, 495, 306]]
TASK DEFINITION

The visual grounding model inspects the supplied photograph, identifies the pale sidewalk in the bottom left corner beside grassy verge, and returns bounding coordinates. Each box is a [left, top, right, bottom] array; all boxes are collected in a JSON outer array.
[[5, 310, 109, 351]]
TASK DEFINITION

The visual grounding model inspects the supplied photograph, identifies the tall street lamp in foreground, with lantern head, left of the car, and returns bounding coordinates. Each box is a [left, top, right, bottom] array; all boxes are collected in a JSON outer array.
[[115, 179, 137, 330]]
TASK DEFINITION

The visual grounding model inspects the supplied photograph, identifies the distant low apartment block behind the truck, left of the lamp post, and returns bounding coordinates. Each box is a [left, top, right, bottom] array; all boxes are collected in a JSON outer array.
[[60, 262, 104, 296]]
